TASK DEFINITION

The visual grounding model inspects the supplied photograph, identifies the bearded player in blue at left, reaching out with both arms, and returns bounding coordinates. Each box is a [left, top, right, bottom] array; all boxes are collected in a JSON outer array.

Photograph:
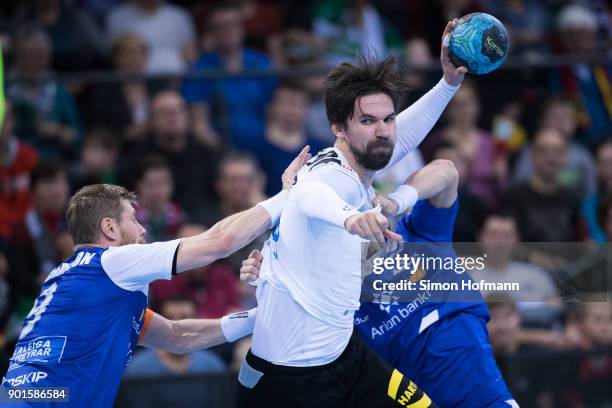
[[1, 148, 310, 407]]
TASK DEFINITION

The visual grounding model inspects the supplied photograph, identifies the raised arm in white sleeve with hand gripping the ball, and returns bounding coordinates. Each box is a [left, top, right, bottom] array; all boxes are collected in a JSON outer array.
[[383, 21, 467, 171]]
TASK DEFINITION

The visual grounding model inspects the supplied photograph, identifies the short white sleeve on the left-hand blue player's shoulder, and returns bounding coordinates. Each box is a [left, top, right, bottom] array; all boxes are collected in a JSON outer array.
[[101, 239, 181, 294]]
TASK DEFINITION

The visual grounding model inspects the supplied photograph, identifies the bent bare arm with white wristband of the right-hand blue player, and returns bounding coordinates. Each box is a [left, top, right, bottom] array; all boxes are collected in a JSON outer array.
[[375, 159, 459, 216]]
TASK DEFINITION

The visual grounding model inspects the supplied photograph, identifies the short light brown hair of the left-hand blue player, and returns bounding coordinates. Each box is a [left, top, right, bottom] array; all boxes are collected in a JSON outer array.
[[66, 184, 136, 245]]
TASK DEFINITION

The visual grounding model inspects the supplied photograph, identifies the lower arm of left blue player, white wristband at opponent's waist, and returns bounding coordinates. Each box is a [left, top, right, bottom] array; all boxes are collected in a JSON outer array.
[[139, 309, 257, 354]]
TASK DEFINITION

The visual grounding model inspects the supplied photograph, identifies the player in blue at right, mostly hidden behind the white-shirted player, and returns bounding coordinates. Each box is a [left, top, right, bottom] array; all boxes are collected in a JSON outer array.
[[241, 160, 518, 408]]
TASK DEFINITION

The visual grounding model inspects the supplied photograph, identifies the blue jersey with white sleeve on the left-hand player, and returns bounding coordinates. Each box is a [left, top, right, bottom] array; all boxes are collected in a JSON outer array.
[[2, 240, 179, 407]]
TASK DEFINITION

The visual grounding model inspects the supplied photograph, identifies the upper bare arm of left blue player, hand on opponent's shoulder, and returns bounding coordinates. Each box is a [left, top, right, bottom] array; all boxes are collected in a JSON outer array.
[[176, 146, 310, 272]]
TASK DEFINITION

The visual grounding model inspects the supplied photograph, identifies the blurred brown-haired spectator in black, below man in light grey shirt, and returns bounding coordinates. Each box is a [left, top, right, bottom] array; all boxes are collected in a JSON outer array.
[[82, 32, 161, 143]]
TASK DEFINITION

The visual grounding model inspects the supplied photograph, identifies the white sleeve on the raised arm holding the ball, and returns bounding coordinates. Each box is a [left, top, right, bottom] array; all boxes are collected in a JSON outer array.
[[381, 78, 459, 171]]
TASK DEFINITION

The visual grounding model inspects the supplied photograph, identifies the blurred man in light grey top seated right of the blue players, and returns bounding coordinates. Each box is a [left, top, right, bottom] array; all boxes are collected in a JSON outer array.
[[472, 213, 559, 326]]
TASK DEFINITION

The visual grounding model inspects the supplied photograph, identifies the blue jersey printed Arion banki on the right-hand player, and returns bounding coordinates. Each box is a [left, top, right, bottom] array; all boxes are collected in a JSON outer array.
[[355, 200, 490, 362]]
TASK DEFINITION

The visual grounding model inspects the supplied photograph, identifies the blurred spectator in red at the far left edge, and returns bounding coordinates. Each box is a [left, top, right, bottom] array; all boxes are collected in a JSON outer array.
[[0, 101, 38, 241]]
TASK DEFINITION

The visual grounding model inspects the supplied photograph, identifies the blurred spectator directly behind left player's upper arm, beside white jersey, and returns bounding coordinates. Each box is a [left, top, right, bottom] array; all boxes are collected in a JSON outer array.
[[209, 152, 267, 276]]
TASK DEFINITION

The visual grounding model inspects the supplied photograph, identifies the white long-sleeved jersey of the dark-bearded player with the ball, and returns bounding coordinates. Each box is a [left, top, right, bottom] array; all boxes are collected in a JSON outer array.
[[252, 80, 458, 366]]
